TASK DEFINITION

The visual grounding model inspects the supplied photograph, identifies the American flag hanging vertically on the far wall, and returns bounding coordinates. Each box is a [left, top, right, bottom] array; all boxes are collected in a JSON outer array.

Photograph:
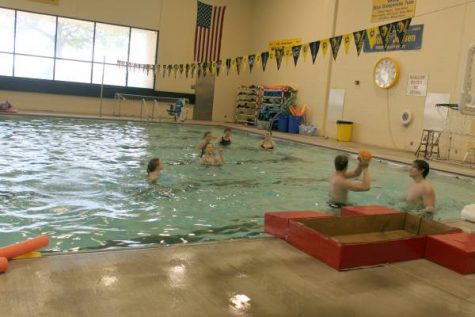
[[195, 1, 226, 62]]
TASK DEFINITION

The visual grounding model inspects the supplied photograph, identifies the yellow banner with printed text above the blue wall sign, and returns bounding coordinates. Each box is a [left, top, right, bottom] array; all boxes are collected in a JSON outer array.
[[371, 0, 416, 23]]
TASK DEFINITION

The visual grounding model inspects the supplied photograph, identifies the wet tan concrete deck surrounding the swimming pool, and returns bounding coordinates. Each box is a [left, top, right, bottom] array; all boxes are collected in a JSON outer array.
[[0, 114, 475, 317]]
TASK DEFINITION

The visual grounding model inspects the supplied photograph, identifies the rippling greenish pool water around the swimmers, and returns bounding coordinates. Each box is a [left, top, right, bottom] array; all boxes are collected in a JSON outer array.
[[0, 116, 475, 251]]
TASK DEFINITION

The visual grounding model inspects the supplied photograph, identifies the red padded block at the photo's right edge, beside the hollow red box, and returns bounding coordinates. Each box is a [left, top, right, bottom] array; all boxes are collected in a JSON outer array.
[[425, 232, 475, 274]]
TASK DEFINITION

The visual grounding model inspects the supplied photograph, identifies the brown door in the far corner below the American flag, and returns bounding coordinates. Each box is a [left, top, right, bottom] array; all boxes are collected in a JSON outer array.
[[193, 74, 214, 121]]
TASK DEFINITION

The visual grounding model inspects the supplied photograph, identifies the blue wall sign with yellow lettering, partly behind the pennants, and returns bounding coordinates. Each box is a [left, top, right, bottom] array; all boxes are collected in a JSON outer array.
[[363, 24, 424, 53]]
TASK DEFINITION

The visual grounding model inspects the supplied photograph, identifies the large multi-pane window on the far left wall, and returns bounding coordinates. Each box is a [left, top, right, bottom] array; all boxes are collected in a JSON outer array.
[[0, 8, 158, 88]]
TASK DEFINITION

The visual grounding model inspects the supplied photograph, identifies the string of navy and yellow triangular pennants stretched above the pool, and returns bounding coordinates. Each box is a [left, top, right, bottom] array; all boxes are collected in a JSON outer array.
[[117, 17, 412, 78]]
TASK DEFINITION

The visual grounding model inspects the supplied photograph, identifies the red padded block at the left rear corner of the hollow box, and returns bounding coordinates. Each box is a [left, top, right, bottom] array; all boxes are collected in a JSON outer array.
[[264, 210, 331, 239]]
